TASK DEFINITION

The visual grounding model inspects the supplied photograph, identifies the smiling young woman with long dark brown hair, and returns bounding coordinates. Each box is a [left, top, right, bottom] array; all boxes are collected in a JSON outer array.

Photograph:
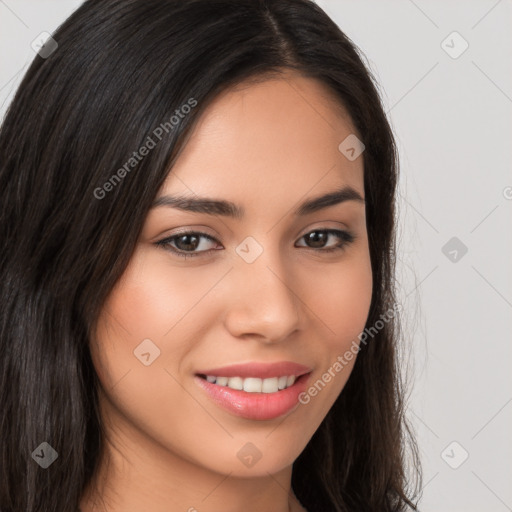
[[0, 0, 419, 512]]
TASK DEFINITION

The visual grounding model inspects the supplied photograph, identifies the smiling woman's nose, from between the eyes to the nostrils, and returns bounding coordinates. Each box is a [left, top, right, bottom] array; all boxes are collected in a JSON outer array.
[[225, 245, 302, 343]]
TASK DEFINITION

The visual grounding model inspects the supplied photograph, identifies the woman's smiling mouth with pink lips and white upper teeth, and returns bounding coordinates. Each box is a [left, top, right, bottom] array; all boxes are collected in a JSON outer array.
[[194, 362, 312, 420]]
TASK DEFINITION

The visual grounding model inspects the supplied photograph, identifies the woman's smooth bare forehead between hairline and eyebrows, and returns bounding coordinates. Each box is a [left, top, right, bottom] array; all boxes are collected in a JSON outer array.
[[162, 73, 364, 208]]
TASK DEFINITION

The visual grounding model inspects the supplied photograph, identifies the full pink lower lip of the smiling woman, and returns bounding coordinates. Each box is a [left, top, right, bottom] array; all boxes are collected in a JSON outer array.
[[194, 373, 310, 420]]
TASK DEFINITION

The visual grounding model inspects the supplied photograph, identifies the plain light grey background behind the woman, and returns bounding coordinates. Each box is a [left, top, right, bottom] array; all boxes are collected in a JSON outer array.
[[0, 0, 512, 512]]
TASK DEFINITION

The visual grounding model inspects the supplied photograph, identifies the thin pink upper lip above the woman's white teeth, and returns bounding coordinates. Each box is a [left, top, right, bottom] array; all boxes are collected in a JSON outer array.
[[197, 361, 312, 379]]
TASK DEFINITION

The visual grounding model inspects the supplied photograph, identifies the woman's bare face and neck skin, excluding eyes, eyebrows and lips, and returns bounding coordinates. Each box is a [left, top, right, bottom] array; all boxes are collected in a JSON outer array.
[[81, 72, 372, 512]]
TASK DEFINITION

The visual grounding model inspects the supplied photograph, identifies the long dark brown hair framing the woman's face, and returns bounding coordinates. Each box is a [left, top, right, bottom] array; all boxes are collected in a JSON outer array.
[[0, 0, 419, 512]]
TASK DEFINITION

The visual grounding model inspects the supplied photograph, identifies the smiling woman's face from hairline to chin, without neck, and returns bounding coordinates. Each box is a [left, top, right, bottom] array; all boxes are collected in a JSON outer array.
[[91, 74, 372, 477]]
